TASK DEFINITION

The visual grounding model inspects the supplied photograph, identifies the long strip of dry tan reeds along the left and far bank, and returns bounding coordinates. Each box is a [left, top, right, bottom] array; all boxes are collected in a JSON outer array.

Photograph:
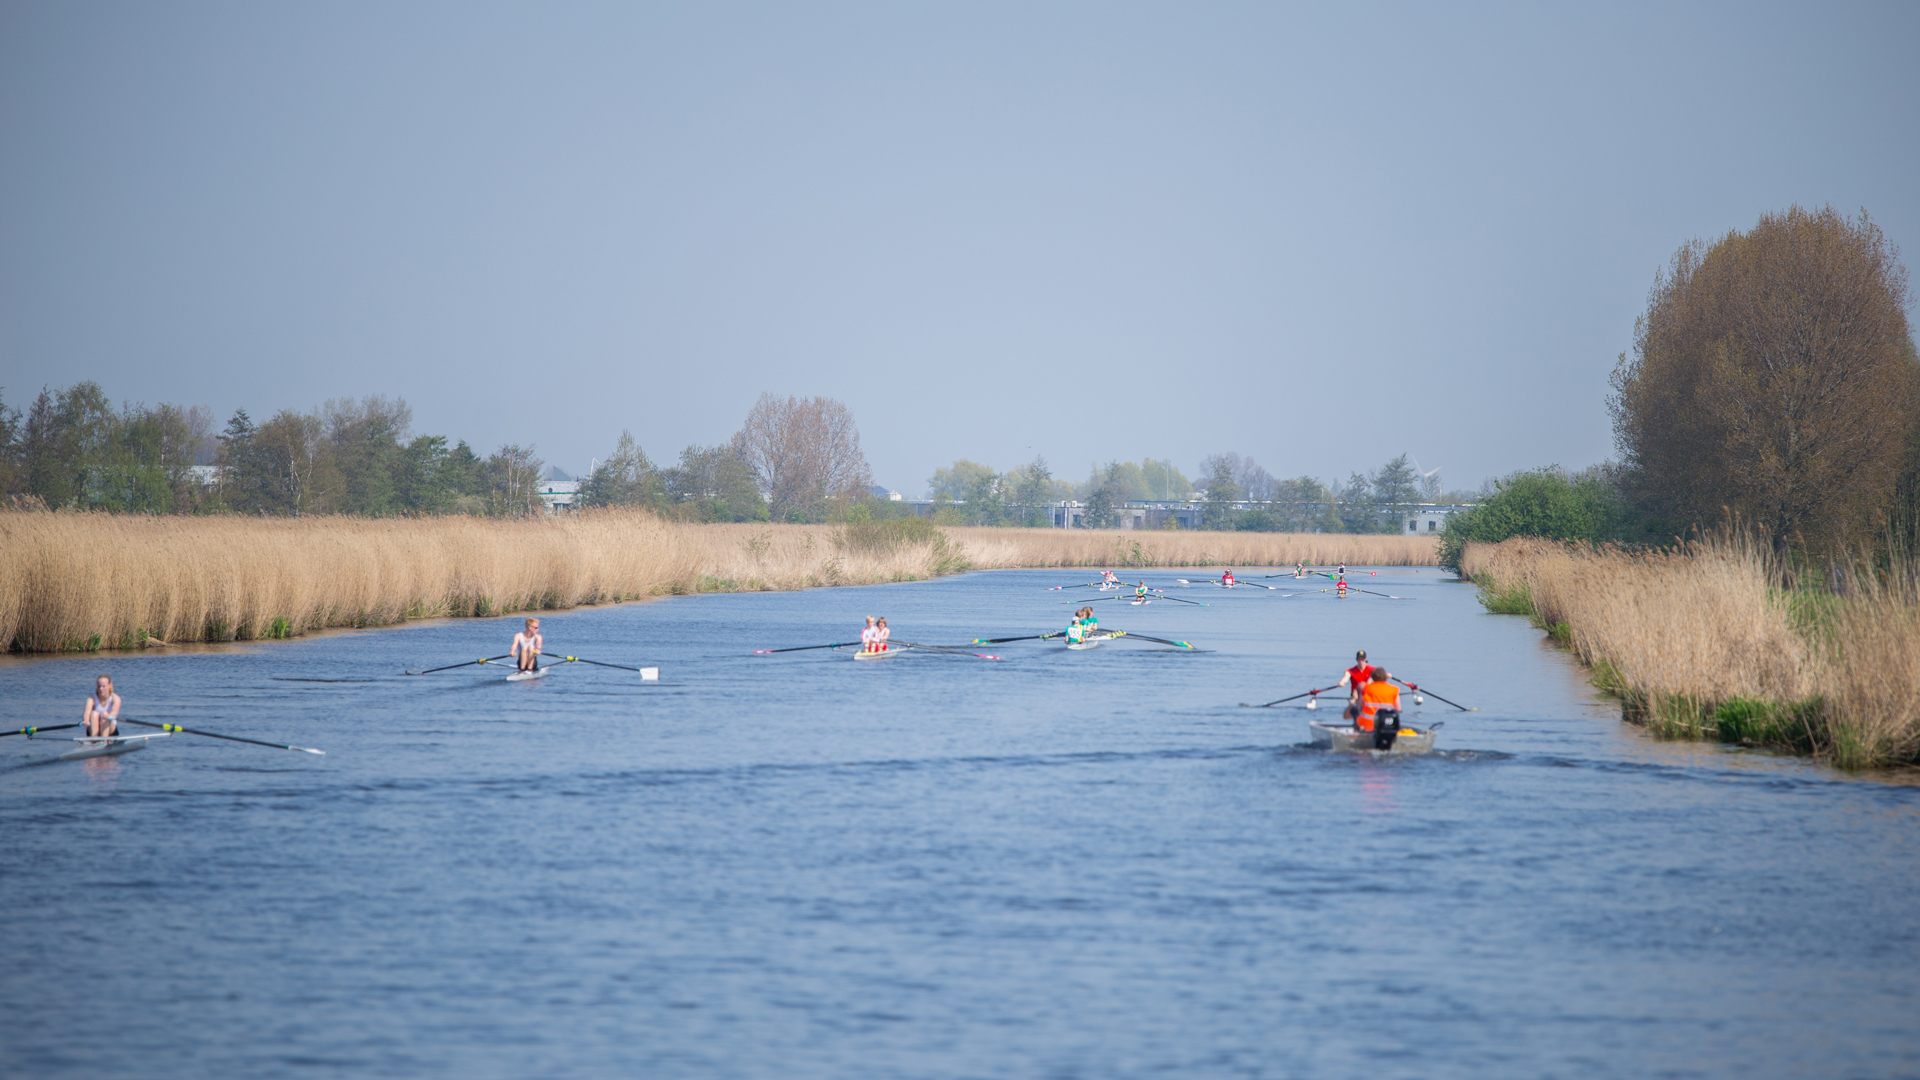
[[0, 511, 1432, 651]]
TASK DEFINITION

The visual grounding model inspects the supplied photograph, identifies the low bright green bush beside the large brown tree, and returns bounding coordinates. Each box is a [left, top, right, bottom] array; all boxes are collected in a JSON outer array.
[[1440, 465, 1622, 573]]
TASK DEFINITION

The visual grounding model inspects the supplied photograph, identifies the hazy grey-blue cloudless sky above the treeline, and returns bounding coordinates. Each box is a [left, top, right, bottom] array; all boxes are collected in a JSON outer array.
[[0, 2, 1920, 494]]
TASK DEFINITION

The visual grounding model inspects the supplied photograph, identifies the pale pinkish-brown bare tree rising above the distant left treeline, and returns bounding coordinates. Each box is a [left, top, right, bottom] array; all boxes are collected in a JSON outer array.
[[733, 394, 874, 521]]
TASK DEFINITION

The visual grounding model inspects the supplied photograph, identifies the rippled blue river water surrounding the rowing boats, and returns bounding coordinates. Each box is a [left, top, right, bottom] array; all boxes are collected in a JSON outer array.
[[0, 571, 1920, 1078]]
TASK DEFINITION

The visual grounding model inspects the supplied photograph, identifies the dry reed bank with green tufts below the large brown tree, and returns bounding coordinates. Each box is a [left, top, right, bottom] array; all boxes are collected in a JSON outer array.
[[1461, 538, 1920, 769]]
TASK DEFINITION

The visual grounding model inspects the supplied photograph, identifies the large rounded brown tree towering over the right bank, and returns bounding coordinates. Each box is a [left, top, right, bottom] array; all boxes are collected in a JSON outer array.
[[1607, 206, 1920, 552]]
